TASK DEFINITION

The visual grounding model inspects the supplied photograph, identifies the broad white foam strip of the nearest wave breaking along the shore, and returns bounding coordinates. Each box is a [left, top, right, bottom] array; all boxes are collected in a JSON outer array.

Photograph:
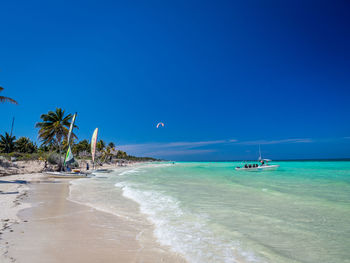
[[115, 182, 258, 263]]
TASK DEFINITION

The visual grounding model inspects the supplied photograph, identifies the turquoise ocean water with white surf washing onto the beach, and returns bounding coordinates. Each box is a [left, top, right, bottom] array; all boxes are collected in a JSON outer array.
[[70, 161, 350, 263]]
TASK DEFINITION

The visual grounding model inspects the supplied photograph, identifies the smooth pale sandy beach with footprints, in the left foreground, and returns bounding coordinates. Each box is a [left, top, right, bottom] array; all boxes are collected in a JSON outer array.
[[0, 170, 185, 262]]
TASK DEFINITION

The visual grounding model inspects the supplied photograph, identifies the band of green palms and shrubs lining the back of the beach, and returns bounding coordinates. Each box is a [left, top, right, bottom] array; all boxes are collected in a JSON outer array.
[[0, 108, 157, 165]]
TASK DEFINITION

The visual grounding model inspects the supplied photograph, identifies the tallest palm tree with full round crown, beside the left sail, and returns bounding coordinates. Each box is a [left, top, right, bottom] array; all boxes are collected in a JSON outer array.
[[35, 108, 78, 169]]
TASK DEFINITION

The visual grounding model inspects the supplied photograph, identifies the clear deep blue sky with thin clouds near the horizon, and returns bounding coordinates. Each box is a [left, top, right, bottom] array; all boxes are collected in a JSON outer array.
[[0, 0, 350, 160]]
